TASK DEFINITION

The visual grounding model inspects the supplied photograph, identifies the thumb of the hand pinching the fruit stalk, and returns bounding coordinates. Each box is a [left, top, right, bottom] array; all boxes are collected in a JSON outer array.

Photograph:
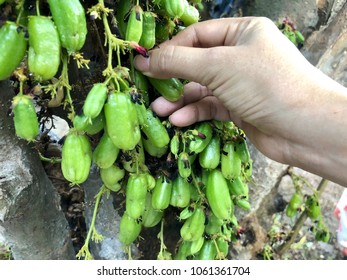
[[134, 45, 224, 85]]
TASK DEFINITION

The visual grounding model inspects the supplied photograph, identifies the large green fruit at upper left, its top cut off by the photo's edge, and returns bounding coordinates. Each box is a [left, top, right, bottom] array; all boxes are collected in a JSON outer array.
[[47, 0, 88, 54]]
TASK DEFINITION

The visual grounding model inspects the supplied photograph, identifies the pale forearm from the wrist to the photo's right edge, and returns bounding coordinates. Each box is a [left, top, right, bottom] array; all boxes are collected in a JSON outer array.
[[288, 68, 347, 186]]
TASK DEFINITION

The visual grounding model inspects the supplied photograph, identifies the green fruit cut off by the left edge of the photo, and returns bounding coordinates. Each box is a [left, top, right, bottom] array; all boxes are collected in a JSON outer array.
[[0, 21, 27, 81]]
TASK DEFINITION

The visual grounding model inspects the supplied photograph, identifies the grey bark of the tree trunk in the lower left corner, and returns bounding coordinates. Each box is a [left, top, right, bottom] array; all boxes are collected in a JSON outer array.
[[0, 82, 75, 259]]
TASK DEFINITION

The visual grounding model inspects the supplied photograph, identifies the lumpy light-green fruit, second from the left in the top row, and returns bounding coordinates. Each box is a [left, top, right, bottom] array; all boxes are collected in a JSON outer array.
[[28, 16, 60, 81]]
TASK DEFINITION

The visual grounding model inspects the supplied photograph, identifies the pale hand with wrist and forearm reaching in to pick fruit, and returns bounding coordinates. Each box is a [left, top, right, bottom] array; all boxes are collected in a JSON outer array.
[[135, 17, 347, 186]]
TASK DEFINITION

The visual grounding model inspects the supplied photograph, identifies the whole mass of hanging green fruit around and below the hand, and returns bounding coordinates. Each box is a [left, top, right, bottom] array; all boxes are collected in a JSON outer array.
[[0, 0, 252, 259]]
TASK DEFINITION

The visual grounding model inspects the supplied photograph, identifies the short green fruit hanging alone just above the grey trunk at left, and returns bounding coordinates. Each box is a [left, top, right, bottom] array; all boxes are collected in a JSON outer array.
[[12, 95, 39, 141]]
